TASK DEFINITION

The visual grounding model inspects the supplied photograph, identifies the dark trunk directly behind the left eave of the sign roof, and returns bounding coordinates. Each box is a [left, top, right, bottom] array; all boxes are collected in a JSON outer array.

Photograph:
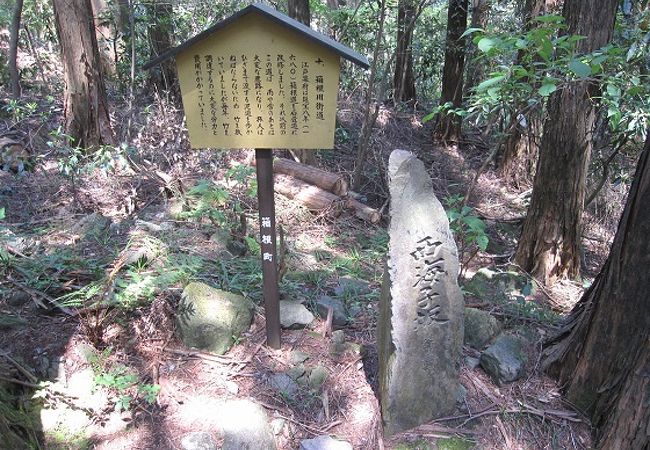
[[146, 0, 178, 93]]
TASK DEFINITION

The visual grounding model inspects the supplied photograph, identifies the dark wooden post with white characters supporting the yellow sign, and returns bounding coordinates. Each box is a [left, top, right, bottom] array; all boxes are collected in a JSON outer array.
[[255, 148, 280, 349]]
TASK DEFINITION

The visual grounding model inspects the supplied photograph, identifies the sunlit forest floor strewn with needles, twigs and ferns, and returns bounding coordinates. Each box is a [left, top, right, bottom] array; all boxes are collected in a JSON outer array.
[[0, 89, 623, 450]]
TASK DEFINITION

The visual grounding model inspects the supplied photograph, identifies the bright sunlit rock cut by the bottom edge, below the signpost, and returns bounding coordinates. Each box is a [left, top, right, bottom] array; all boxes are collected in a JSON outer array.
[[220, 400, 276, 450]]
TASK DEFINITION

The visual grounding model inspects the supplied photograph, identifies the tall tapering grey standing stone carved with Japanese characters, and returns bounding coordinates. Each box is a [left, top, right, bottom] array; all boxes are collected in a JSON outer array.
[[377, 150, 463, 435]]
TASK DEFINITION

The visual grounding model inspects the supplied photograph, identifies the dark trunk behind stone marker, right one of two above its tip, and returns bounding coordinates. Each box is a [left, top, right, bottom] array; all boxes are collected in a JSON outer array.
[[434, 0, 467, 142]]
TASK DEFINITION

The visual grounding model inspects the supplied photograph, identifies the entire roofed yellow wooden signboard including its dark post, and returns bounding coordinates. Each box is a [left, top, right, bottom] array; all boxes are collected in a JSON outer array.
[[144, 4, 368, 348]]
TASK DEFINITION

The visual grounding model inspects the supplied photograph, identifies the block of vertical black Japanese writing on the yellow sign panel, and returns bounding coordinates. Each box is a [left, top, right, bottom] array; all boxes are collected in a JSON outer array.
[[187, 53, 328, 142]]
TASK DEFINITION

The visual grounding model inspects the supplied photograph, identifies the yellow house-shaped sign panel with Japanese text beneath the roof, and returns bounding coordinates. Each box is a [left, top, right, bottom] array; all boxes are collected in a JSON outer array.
[[176, 14, 340, 148]]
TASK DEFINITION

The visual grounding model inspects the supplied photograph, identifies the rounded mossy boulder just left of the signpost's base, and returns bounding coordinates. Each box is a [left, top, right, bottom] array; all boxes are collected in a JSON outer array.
[[177, 282, 254, 355]]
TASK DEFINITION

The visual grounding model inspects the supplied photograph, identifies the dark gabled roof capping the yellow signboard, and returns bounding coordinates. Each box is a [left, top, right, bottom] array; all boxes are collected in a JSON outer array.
[[144, 3, 370, 69]]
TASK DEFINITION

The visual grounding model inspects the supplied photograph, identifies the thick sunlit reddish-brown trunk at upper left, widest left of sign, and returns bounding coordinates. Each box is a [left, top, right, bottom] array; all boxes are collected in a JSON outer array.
[[53, 0, 114, 147]]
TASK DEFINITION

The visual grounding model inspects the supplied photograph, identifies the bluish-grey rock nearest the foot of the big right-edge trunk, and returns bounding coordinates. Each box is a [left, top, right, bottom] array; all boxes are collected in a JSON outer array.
[[481, 334, 528, 385]]
